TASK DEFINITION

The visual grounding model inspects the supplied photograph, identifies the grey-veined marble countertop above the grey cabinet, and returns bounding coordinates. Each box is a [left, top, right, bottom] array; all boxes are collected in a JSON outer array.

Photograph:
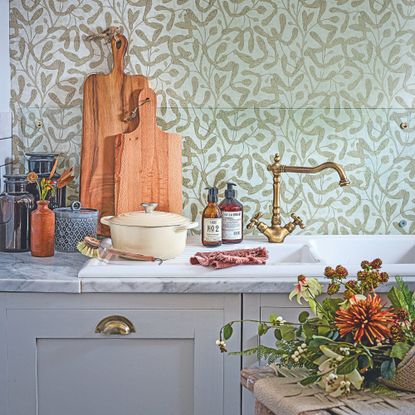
[[0, 252, 302, 293]]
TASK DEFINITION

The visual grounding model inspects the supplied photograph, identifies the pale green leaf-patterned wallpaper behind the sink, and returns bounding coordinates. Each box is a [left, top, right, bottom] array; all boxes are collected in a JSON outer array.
[[10, 0, 415, 234]]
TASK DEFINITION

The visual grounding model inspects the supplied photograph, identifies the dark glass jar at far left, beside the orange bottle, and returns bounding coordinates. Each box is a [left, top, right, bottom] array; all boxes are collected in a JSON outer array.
[[0, 175, 35, 252]]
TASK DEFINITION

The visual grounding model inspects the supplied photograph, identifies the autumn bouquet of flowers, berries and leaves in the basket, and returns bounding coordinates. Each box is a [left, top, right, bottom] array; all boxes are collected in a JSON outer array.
[[216, 258, 415, 397]]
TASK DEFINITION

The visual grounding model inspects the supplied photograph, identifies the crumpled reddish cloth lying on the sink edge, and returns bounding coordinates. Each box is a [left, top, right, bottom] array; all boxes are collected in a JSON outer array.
[[190, 247, 268, 269]]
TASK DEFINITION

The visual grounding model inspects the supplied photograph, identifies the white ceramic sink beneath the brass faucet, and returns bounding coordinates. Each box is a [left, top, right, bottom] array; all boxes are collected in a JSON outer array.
[[79, 235, 415, 281]]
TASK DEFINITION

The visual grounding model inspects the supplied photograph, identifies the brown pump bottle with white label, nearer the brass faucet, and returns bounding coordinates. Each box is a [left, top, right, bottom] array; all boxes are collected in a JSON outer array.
[[219, 183, 243, 244]]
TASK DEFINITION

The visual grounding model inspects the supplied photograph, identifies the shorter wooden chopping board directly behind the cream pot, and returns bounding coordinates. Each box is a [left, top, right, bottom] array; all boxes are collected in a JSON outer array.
[[114, 88, 183, 215]]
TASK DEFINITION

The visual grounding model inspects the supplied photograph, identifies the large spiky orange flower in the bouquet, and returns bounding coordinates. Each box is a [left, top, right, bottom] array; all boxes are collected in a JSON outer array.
[[336, 294, 396, 344]]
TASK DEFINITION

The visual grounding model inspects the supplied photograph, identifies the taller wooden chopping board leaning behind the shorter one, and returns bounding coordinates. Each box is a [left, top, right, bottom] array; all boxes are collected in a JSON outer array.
[[80, 35, 148, 235]]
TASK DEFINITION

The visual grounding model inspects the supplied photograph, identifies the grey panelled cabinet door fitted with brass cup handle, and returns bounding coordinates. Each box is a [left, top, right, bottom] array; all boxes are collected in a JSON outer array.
[[7, 309, 224, 415]]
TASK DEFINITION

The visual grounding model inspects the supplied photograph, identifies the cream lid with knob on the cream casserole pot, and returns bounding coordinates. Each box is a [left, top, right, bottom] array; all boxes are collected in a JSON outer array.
[[111, 203, 190, 228]]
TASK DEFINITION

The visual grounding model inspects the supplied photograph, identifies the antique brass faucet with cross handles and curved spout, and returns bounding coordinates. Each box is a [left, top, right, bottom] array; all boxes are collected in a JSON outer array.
[[247, 153, 350, 243]]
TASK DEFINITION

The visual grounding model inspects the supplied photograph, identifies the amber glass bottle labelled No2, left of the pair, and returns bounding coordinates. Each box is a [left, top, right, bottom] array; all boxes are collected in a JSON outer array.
[[202, 187, 222, 247]]
